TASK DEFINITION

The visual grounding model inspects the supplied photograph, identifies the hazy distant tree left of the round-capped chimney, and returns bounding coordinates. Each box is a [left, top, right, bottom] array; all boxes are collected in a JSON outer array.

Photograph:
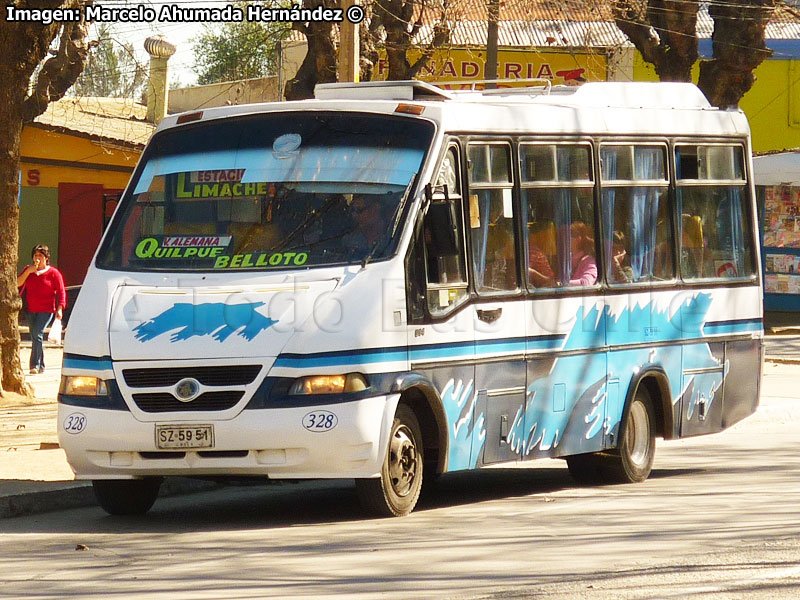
[[72, 23, 147, 99]]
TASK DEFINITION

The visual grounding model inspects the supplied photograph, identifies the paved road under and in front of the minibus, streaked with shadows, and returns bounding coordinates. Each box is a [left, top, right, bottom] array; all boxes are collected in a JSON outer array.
[[0, 364, 800, 600]]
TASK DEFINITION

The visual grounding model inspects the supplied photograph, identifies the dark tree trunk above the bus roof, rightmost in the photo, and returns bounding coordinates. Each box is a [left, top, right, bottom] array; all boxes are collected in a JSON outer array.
[[697, 0, 775, 108]]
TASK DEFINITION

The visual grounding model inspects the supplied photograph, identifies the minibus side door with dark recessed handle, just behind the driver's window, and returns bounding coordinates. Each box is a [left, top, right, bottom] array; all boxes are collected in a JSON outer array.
[[467, 142, 525, 464]]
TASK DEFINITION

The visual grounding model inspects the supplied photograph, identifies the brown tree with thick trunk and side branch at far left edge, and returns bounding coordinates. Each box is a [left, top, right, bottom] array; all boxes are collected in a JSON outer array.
[[0, 0, 92, 394]]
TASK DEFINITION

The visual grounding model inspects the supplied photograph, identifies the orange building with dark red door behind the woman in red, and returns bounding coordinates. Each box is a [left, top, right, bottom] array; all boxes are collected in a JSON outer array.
[[19, 98, 154, 285]]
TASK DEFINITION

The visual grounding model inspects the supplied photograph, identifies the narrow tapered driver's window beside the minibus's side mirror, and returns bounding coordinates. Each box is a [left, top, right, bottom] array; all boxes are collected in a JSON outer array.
[[422, 146, 467, 317]]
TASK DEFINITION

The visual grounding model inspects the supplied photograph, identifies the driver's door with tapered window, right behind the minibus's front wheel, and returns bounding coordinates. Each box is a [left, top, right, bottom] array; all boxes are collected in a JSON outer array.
[[406, 145, 483, 471]]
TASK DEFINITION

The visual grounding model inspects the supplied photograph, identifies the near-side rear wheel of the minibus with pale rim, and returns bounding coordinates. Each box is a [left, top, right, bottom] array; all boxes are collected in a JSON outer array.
[[601, 386, 656, 483]]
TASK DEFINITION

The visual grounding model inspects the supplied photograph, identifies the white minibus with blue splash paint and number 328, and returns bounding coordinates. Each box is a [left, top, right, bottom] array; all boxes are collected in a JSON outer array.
[[59, 81, 763, 516]]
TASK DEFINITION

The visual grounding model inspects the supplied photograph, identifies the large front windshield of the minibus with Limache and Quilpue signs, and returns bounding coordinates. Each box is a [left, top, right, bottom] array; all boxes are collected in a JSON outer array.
[[97, 112, 433, 271]]
